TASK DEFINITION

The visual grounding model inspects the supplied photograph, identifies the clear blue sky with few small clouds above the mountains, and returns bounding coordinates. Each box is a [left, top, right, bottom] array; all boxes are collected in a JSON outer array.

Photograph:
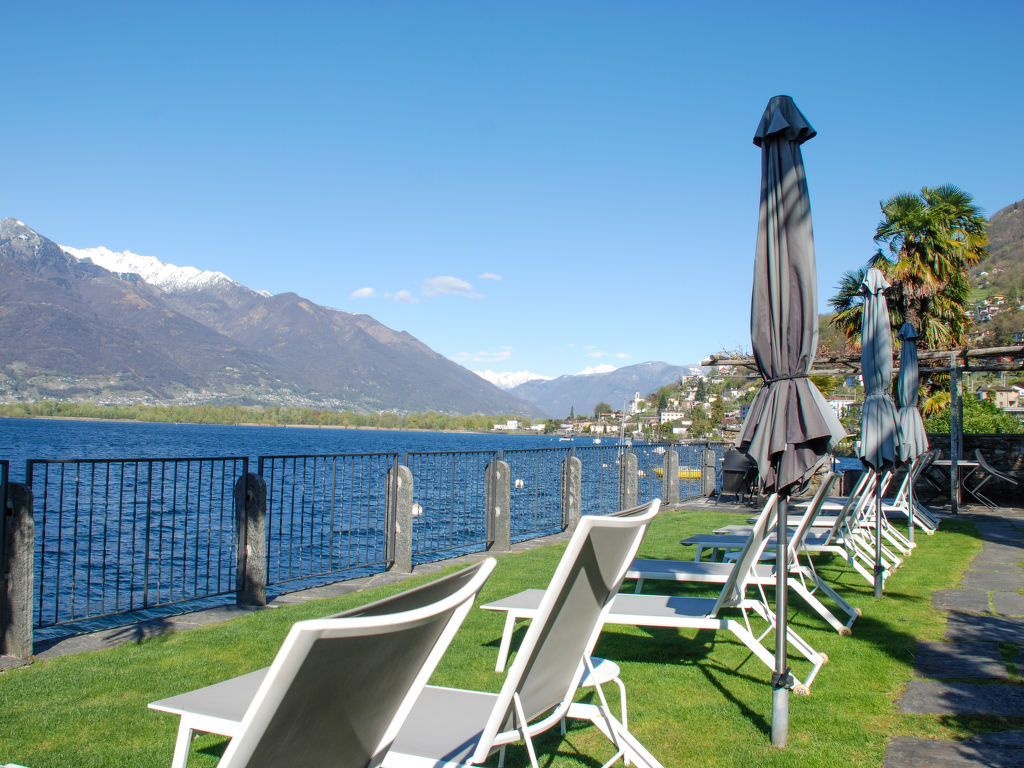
[[0, 0, 1024, 376]]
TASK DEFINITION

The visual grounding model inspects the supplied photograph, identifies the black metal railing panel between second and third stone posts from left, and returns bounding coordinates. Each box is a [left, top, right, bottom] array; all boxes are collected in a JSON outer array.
[[258, 454, 398, 586]]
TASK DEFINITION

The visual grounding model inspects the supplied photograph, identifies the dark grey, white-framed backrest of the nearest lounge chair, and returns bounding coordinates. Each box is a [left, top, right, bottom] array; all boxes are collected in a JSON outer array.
[[220, 558, 495, 768]]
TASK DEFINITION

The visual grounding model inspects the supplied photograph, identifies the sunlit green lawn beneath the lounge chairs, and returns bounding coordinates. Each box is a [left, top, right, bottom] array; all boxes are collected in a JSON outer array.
[[0, 512, 1007, 768]]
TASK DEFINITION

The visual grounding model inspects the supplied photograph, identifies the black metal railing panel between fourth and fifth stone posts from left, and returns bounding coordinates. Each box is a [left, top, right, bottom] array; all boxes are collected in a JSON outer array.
[[501, 449, 571, 541]]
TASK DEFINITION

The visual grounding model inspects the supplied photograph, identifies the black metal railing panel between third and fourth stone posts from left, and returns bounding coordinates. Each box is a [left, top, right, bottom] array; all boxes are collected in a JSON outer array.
[[404, 451, 499, 561]]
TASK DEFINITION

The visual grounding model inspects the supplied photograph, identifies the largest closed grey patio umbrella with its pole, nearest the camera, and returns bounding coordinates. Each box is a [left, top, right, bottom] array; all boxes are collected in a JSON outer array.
[[737, 96, 846, 746]]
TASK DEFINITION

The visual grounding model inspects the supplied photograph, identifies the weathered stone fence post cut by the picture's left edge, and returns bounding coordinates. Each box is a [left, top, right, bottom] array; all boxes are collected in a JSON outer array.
[[0, 482, 36, 658]]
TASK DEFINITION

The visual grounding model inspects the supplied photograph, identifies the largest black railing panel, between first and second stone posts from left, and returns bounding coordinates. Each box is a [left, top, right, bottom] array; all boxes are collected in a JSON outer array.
[[26, 457, 248, 627]]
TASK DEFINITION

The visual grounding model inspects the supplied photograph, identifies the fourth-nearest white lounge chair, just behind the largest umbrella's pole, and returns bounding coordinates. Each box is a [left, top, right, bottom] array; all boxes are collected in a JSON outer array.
[[626, 474, 861, 635]]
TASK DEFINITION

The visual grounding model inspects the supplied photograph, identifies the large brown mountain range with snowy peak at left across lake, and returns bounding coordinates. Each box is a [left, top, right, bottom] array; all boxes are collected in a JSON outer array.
[[0, 218, 541, 416]]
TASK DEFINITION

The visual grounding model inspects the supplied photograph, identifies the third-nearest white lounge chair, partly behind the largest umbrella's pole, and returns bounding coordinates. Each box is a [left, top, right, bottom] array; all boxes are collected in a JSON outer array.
[[481, 498, 827, 693]]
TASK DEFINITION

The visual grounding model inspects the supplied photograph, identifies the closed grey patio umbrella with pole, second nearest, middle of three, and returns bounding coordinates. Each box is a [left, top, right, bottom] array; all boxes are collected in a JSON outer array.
[[860, 267, 899, 597]]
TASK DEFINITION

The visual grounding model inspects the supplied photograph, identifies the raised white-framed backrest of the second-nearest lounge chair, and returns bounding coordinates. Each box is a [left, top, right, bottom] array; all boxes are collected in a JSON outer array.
[[471, 499, 662, 763]]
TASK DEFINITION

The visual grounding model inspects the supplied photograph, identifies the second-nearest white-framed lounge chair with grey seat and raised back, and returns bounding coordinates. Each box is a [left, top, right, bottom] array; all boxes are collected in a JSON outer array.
[[384, 499, 660, 768]]
